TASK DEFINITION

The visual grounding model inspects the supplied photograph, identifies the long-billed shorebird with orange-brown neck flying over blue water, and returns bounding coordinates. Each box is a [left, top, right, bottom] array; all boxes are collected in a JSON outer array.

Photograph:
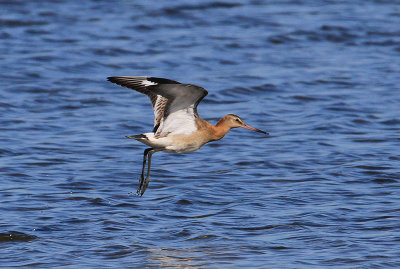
[[108, 76, 268, 196]]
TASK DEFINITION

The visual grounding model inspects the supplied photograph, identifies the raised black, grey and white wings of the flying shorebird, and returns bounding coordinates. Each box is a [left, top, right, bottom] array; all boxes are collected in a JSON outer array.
[[108, 76, 208, 136]]
